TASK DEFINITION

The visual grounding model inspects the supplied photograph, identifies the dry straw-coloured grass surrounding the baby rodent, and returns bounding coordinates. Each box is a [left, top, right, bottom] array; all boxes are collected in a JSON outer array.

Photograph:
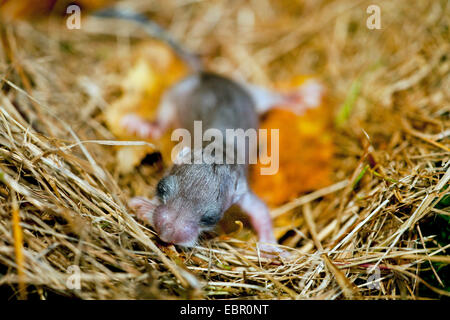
[[0, 0, 450, 299]]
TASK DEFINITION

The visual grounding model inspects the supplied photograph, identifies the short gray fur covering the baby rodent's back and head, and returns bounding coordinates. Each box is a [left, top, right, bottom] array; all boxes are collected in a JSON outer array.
[[156, 72, 258, 236]]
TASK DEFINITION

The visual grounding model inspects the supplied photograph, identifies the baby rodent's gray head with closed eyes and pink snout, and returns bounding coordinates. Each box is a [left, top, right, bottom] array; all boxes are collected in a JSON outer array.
[[132, 146, 235, 247]]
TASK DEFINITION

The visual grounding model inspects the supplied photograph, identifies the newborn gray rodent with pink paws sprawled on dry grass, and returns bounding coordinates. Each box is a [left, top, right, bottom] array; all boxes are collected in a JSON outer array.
[[96, 9, 323, 253]]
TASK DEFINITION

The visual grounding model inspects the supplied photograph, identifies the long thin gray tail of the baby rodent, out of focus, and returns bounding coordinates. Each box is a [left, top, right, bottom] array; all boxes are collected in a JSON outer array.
[[93, 7, 203, 71]]
